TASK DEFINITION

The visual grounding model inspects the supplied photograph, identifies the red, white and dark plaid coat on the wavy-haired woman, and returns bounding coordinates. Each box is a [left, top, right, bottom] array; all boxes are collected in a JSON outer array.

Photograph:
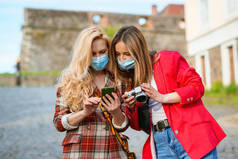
[[53, 73, 127, 159]]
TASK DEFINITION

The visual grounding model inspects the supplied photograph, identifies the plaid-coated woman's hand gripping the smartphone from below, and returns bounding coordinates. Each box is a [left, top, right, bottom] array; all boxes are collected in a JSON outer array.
[[101, 92, 121, 116]]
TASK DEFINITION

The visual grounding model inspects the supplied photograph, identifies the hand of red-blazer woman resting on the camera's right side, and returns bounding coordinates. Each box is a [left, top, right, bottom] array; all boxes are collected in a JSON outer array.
[[141, 83, 163, 103]]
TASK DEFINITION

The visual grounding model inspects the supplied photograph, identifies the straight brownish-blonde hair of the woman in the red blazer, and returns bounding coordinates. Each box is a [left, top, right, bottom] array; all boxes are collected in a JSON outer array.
[[109, 26, 153, 87]]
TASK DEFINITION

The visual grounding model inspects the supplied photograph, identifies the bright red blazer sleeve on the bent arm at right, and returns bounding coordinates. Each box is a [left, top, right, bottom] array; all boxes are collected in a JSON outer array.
[[174, 52, 204, 106]]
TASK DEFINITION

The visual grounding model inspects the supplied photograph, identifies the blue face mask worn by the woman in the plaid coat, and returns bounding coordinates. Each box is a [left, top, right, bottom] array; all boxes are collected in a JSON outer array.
[[91, 54, 109, 71]]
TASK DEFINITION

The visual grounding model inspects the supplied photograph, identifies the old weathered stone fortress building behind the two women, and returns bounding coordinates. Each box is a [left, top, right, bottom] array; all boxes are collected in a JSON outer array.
[[20, 5, 187, 85]]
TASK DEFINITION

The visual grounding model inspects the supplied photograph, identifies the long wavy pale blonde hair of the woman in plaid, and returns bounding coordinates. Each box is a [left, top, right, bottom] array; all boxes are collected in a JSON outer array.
[[57, 26, 110, 112]]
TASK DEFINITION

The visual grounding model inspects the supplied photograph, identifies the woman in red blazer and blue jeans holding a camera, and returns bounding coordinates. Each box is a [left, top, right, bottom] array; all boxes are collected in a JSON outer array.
[[111, 26, 226, 159]]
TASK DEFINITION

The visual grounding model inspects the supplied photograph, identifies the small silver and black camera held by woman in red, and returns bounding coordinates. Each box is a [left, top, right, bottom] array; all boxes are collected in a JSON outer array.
[[125, 86, 147, 103]]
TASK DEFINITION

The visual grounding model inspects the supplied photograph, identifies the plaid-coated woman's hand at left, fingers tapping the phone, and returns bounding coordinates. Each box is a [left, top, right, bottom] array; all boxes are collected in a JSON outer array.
[[82, 97, 101, 116]]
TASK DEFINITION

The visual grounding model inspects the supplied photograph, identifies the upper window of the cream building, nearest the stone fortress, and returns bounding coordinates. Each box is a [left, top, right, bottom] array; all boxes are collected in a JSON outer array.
[[199, 0, 209, 31]]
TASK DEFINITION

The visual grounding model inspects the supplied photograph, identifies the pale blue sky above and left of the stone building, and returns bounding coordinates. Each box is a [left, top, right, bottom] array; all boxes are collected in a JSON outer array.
[[0, 0, 184, 73]]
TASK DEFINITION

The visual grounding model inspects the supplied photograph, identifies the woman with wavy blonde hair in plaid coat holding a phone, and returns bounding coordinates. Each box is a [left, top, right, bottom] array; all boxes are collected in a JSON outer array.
[[53, 26, 128, 159]]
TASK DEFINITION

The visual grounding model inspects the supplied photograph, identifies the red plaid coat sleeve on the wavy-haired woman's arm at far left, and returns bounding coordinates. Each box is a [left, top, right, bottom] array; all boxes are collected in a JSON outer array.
[[53, 88, 70, 132]]
